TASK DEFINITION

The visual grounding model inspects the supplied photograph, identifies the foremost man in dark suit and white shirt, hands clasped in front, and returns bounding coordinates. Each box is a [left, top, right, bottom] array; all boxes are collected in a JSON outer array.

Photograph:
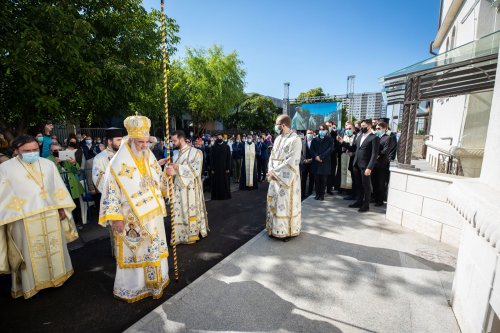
[[339, 119, 379, 213]]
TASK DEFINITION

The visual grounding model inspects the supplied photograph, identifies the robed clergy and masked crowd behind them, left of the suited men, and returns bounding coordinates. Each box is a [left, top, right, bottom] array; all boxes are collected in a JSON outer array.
[[0, 115, 302, 302]]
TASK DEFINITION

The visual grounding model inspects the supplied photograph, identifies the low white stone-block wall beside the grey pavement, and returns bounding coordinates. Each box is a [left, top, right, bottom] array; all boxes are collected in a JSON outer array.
[[386, 168, 463, 247]]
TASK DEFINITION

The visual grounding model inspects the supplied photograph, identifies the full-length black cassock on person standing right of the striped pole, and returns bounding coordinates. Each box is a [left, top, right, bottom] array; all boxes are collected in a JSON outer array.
[[210, 143, 231, 200]]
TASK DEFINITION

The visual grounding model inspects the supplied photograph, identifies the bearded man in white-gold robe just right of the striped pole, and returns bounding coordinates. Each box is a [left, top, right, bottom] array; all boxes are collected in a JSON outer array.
[[164, 131, 209, 244]]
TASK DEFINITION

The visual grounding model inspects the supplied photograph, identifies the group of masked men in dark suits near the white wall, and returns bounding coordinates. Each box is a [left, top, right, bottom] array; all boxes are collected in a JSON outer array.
[[301, 118, 398, 212]]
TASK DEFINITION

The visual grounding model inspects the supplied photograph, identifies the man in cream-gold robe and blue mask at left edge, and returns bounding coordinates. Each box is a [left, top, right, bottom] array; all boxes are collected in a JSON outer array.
[[0, 135, 78, 298]]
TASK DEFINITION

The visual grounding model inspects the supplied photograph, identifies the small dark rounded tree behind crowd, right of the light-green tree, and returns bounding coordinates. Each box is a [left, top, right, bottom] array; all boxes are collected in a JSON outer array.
[[228, 94, 276, 131]]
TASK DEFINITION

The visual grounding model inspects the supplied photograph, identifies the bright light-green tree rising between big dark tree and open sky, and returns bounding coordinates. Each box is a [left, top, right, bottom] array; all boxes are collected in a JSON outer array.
[[184, 45, 246, 129]]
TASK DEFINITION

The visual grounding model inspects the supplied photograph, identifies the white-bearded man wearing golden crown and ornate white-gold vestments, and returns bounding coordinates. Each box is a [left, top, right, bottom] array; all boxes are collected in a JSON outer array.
[[99, 115, 169, 303]]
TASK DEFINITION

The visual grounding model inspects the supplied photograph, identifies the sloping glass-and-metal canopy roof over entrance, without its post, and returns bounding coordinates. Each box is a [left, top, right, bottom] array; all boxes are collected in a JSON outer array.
[[382, 31, 500, 104]]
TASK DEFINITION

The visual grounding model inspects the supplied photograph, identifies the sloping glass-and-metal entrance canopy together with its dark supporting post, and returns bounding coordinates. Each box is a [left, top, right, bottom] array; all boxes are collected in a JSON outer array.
[[381, 30, 500, 168]]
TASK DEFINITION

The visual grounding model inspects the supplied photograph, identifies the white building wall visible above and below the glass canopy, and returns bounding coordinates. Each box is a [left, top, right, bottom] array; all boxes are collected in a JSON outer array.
[[427, 0, 500, 177]]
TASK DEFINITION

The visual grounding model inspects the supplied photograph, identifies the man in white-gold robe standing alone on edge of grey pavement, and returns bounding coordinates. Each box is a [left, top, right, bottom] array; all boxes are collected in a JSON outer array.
[[266, 115, 302, 241]]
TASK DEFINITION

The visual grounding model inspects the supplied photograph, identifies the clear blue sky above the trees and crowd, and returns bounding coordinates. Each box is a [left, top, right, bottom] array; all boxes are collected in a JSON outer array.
[[144, 0, 439, 98]]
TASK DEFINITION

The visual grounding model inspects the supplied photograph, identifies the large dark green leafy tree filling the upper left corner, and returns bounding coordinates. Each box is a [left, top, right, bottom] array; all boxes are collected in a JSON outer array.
[[0, 0, 179, 136]]
